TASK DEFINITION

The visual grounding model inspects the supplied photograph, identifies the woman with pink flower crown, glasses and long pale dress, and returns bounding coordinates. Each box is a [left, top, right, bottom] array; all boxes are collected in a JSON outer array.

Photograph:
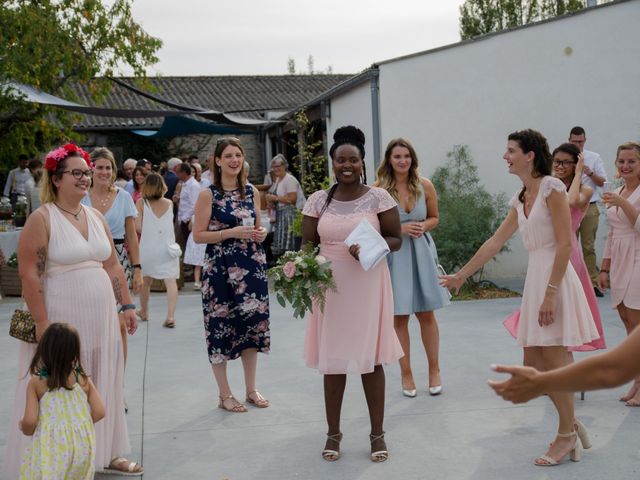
[[3, 144, 143, 478]]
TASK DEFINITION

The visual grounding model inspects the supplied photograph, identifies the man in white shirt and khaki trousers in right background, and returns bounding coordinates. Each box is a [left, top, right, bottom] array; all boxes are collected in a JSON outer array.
[[569, 126, 607, 297]]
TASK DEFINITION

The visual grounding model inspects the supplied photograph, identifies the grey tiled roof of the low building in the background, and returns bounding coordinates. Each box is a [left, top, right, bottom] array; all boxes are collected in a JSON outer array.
[[73, 75, 352, 130]]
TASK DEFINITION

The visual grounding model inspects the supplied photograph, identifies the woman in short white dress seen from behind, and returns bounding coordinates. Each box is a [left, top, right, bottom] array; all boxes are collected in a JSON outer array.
[[136, 172, 182, 328]]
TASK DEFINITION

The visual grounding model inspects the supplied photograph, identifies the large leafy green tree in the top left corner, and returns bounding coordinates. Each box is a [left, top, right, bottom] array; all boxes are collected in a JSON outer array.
[[0, 0, 162, 166]]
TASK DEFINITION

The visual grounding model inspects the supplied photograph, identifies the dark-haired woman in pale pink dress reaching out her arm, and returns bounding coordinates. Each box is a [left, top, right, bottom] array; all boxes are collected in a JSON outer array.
[[442, 130, 599, 466]]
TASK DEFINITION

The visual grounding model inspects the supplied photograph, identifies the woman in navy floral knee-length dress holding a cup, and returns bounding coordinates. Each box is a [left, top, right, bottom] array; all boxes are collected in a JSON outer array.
[[193, 137, 270, 412]]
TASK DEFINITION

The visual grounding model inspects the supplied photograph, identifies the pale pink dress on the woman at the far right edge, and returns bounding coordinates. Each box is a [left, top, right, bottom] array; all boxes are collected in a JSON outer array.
[[602, 187, 640, 310]]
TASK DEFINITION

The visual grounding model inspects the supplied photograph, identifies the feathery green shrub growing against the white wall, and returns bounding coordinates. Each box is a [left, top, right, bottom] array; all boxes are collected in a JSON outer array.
[[431, 145, 508, 279]]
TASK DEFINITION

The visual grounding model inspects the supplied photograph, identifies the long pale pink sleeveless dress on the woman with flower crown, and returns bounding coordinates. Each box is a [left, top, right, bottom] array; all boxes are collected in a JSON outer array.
[[4, 203, 130, 478]]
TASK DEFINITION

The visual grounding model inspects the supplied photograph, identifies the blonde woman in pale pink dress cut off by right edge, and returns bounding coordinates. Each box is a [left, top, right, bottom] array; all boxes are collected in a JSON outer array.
[[598, 142, 640, 407]]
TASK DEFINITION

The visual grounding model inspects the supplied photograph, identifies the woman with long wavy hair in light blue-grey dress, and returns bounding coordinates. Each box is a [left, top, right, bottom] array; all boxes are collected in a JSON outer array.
[[377, 138, 449, 397]]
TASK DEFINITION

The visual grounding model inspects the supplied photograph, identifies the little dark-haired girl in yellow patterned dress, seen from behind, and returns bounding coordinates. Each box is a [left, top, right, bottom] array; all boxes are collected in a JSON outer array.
[[20, 323, 105, 480]]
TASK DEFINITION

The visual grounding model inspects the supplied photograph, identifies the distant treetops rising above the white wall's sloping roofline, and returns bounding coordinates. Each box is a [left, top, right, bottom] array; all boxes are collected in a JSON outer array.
[[460, 0, 585, 40]]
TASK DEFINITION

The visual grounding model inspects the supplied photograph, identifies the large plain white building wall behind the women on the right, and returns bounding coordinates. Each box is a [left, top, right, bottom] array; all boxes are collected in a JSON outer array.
[[368, 1, 640, 277]]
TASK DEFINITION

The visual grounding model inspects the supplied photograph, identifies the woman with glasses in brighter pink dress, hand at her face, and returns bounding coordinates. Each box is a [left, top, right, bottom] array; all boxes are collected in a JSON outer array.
[[553, 143, 607, 352]]
